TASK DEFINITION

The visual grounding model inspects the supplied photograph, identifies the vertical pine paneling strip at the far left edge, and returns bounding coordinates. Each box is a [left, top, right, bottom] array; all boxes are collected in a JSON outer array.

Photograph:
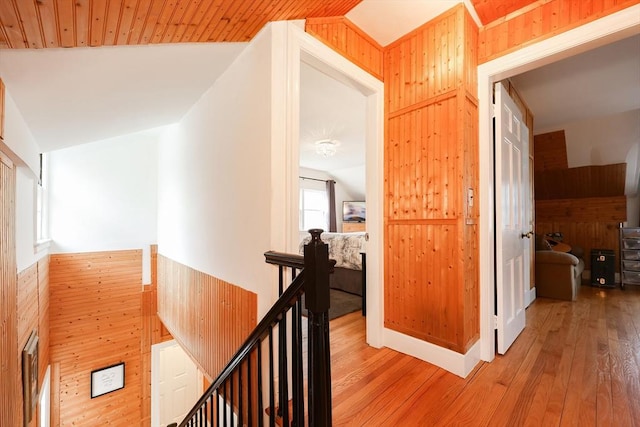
[[0, 151, 22, 426]]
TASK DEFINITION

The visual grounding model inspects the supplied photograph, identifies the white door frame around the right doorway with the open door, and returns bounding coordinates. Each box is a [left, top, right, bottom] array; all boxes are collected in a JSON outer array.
[[478, 5, 640, 362]]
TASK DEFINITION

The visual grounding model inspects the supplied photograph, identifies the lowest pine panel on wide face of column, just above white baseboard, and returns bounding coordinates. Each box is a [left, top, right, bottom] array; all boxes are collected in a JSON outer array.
[[384, 221, 463, 352]]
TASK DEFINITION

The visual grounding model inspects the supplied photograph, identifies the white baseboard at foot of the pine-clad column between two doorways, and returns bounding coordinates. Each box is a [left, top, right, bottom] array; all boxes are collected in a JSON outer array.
[[383, 328, 480, 378]]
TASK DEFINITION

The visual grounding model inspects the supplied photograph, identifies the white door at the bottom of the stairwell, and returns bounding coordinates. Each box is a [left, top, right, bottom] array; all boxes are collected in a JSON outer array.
[[151, 341, 203, 427]]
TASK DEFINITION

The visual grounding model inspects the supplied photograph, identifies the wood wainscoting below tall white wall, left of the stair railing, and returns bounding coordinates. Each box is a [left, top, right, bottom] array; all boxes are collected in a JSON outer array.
[[158, 255, 257, 378]]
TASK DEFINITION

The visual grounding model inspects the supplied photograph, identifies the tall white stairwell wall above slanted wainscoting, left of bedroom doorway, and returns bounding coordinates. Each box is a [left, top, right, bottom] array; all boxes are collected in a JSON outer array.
[[158, 26, 277, 316]]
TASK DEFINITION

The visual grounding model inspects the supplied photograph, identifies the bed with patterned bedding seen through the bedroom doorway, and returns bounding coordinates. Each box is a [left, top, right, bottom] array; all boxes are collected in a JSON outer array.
[[300, 232, 366, 296]]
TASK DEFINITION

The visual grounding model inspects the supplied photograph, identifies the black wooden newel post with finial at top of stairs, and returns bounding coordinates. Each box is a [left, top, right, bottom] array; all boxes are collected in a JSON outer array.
[[304, 229, 332, 427]]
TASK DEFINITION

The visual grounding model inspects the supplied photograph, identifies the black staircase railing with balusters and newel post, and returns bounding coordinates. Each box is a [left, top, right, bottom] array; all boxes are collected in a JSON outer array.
[[180, 229, 335, 427]]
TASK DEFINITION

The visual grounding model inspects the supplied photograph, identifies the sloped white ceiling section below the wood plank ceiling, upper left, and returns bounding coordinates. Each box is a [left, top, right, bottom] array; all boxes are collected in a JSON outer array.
[[0, 43, 246, 152]]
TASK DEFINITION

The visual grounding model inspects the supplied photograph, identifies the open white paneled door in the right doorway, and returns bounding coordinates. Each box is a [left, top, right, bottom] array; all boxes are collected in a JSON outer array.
[[494, 83, 532, 354]]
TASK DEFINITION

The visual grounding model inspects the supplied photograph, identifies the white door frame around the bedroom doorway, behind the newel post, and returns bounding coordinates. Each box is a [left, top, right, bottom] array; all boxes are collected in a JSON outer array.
[[271, 21, 384, 348]]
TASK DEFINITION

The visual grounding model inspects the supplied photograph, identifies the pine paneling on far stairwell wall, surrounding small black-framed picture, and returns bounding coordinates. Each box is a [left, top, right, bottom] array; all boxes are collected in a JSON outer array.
[[49, 250, 143, 426]]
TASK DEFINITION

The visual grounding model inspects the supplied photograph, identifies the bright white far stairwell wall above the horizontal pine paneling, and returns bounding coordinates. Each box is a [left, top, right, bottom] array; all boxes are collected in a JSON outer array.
[[49, 128, 160, 264]]
